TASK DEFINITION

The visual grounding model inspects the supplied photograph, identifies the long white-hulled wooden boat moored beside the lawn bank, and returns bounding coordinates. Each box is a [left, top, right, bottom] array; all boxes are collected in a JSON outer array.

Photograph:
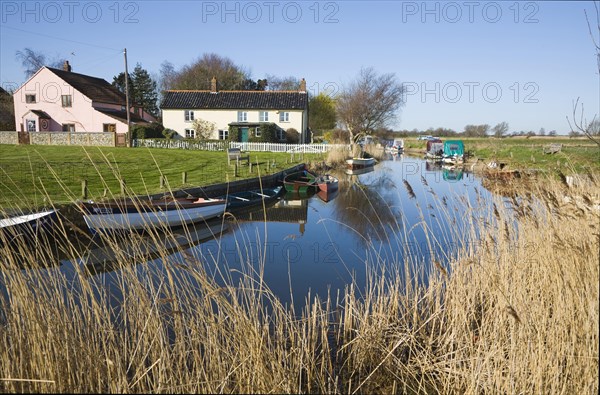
[[80, 196, 227, 233]]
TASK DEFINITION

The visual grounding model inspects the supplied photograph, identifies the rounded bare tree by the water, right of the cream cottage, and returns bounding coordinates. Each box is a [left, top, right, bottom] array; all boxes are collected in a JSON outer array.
[[336, 67, 404, 144]]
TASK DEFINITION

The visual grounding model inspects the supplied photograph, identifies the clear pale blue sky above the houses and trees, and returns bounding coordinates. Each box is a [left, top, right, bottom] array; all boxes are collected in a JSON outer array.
[[0, 0, 600, 134]]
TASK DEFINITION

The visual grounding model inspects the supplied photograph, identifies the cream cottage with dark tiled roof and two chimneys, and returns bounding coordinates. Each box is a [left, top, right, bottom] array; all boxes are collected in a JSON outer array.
[[160, 78, 310, 143]]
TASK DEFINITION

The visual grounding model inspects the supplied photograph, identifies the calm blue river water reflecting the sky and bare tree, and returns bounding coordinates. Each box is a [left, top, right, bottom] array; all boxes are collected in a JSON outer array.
[[0, 155, 491, 310]]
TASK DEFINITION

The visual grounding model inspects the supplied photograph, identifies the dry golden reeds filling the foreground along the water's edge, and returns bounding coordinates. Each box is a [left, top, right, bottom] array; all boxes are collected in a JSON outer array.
[[0, 169, 600, 394]]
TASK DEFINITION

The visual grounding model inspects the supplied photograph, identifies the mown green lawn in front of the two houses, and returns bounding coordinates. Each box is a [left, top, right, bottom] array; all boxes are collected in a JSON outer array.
[[0, 145, 323, 208]]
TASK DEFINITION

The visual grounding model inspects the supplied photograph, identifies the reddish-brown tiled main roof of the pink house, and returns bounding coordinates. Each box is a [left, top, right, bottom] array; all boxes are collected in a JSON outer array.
[[47, 67, 125, 105]]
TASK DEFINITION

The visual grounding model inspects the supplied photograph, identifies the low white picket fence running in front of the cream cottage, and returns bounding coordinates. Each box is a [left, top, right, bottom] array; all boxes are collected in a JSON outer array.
[[133, 139, 350, 153]]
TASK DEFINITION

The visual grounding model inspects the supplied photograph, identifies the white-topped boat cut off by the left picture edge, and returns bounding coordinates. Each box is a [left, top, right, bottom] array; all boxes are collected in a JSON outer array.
[[0, 209, 58, 245]]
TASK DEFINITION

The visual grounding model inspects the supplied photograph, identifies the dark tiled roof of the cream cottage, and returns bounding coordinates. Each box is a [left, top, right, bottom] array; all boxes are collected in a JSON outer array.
[[160, 91, 308, 110]]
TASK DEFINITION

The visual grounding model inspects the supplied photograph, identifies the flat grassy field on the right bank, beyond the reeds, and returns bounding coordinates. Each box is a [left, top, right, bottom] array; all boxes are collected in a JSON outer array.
[[404, 137, 600, 173]]
